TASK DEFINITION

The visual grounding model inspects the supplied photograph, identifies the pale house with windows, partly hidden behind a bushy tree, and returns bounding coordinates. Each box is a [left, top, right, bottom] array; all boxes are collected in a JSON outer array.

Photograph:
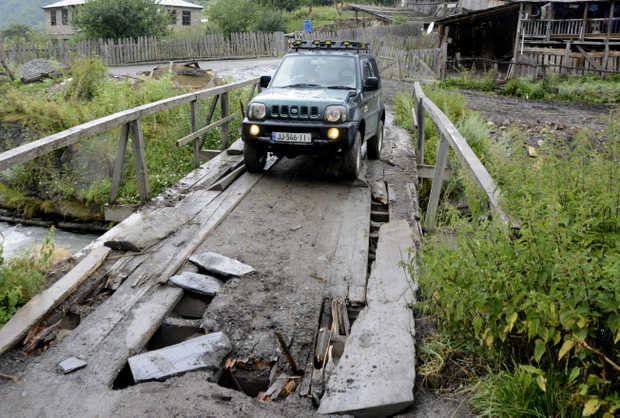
[[43, 0, 204, 39]]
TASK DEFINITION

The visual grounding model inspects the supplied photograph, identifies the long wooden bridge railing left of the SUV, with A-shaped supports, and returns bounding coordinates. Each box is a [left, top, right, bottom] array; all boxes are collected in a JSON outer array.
[[0, 77, 260, 203]]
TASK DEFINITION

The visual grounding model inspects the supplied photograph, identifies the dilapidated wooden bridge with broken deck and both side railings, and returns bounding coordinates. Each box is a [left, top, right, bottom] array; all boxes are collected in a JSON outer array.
[[0, 76, 512, 416]]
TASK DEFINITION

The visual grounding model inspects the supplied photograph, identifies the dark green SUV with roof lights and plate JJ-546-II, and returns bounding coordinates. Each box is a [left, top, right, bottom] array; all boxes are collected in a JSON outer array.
[[242, 41, 385, 179]]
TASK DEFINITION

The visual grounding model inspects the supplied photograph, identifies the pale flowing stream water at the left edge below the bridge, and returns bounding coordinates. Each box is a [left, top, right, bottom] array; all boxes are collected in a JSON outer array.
[[0, 222, 98, 259]]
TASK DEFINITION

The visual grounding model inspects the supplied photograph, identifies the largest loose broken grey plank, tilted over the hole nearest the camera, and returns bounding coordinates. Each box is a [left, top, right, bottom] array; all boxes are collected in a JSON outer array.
[[128, 332, 231, 383]]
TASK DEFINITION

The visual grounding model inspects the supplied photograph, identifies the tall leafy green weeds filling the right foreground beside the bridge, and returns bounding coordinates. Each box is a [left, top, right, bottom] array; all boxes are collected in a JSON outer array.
[[397, 85, 620, 417]]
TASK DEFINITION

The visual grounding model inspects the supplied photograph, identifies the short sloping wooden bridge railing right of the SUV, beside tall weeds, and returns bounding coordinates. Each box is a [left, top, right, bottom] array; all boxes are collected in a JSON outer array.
[[412, 82, 519, 229]]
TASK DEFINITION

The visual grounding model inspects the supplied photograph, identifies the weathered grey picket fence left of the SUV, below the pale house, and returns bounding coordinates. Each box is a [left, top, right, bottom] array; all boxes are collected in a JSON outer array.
[[0, 32, 287, 66]]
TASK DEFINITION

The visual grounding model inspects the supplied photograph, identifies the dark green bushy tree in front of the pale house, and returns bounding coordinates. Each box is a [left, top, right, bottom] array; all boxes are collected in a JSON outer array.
[[72, 0, 175, 39]]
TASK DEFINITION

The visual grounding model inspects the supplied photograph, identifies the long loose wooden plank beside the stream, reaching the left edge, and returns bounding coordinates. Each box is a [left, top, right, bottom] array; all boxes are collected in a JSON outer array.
[[0, 246, 110, 355]]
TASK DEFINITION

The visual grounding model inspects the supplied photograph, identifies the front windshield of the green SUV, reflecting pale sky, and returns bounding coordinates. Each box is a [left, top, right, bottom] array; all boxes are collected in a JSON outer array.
[[271, 54, 356, 89]]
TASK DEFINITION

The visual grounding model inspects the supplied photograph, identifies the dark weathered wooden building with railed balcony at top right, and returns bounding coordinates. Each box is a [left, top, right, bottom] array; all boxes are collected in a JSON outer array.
[[437, 0, 620, 77]]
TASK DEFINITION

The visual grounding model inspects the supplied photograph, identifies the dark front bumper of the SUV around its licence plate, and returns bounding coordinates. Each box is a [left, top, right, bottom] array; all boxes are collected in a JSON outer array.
[[241, 118, 357, 156]]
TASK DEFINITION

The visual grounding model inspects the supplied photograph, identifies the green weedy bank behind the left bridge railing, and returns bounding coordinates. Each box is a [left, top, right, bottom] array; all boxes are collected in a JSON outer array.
[[0, 58, 247, 220]]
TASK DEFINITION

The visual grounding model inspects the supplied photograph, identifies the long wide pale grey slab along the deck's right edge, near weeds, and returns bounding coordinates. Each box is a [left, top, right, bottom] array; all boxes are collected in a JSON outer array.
[[319, 220, 415, 417]]
